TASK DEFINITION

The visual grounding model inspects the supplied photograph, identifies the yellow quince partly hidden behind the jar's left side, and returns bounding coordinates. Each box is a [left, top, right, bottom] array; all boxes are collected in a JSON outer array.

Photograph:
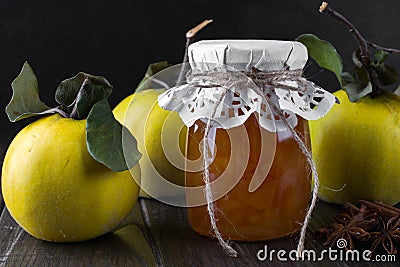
[[113, 89, 187, 197]]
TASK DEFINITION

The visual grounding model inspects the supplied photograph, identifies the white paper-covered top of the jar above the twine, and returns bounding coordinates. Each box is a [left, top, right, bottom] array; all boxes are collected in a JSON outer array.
[[188, 40, 308, 72]]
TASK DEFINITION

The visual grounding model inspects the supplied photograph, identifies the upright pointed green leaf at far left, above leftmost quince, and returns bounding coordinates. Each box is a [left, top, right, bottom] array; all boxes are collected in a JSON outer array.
[[6, 62, 49, 122]]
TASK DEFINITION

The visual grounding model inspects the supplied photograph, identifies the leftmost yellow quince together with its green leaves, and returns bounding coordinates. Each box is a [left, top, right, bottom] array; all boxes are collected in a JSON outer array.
[[1, 63, 140, 242]]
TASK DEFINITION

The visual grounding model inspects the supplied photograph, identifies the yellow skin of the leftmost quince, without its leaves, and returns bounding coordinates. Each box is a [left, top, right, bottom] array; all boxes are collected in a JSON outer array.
[[2, 114, 140, 242]]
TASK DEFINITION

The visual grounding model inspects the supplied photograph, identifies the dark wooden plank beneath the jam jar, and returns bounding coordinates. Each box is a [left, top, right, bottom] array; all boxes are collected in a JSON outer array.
[[141, 200, 395, 266]]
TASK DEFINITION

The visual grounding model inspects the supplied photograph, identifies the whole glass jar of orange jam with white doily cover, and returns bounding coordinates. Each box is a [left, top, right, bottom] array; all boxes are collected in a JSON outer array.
[[159, 40, 335, 241]]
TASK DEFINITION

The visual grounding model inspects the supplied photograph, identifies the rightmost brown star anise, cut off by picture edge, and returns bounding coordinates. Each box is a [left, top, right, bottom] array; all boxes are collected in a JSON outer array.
[[371, 214, 400, 254]]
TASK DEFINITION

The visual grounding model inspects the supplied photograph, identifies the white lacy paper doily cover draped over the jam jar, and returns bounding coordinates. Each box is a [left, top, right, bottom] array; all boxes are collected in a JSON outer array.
[[158, 40, 335, 132]]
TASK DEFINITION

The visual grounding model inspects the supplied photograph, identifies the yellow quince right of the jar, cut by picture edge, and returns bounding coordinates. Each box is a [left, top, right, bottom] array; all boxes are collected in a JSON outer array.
[[309, 90, 400, 205]]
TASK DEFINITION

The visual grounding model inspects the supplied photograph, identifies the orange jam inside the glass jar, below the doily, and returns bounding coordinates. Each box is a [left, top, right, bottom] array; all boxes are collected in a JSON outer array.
[[186, 114, 311, 241]]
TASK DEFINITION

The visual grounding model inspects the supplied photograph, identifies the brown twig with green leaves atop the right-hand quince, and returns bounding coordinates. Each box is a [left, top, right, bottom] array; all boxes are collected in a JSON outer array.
[[297, 2, 400, 102]]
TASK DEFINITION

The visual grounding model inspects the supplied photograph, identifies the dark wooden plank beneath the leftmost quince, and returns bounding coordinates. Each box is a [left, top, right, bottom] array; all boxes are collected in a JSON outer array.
[[0, 205, 156, 266]]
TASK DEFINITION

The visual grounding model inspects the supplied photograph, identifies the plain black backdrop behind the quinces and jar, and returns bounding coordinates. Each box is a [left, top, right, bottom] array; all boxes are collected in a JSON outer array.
[[0, 0, 400, 159]]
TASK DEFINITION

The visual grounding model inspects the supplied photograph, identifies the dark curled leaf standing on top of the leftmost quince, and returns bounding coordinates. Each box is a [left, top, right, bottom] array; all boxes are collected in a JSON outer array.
[[56, 72, 113, 107]]
